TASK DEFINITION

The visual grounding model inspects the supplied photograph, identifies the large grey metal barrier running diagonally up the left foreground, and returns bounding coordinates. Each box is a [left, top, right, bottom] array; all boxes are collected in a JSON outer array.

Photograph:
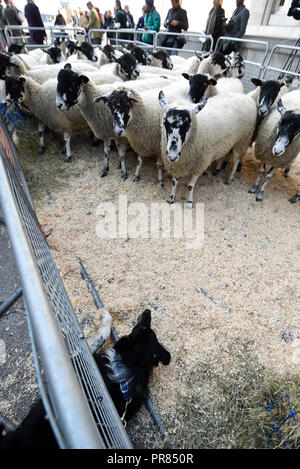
[[0, 116, 132, 449]]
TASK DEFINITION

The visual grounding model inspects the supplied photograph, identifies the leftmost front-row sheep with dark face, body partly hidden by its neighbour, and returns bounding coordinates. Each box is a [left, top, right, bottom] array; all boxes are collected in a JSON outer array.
[[5, 76, 88, 158]]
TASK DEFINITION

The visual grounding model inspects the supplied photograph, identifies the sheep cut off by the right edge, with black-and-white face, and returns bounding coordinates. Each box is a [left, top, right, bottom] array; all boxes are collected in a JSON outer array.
[[250, 90, 300, 202]]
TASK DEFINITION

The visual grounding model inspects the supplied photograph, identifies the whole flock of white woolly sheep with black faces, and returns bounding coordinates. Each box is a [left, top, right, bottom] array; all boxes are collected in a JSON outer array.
[[0, 41, 300, 208]]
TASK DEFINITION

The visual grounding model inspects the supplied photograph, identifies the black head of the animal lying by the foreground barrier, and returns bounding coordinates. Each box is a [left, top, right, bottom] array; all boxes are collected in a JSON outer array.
[[114, 309, 171, 376]]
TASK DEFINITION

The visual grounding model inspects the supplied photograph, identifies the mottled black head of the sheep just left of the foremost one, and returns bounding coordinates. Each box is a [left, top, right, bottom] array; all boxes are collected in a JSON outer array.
[[95, 90, 139, 137]]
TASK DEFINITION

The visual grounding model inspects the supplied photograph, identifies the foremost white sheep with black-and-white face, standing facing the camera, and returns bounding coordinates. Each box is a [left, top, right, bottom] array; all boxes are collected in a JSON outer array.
[[159, 92, 257, 208]]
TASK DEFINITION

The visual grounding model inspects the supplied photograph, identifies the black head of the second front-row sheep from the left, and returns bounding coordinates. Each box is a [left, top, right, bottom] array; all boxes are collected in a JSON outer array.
[[56, 64, 89, 111]]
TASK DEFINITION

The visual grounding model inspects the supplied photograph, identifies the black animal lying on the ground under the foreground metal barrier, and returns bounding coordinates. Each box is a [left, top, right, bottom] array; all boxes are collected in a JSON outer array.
[[0, 309, 171, 449]]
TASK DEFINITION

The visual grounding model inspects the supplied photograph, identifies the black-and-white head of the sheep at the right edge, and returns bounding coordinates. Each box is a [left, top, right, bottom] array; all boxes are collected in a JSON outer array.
[[272, 99, 300, 156]]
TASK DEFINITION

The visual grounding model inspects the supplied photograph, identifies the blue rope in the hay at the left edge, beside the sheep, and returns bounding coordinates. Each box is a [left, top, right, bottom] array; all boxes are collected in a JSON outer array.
[[0, 103, 38, 138]]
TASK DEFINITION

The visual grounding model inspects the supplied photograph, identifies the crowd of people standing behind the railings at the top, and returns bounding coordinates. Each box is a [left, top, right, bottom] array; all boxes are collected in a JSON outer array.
[[0, 0, 250, 53]]
